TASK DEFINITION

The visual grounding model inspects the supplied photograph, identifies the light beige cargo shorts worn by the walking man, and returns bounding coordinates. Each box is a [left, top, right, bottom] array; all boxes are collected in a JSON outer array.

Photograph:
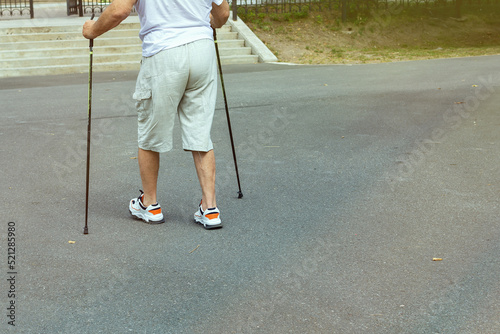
[[133, 39, 217, 152]]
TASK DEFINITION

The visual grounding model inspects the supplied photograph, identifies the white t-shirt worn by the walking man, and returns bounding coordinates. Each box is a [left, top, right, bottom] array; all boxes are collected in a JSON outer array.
[[135, 0, 223, 57]]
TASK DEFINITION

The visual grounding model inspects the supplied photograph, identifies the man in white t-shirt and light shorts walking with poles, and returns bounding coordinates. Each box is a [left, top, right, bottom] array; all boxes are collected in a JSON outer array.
[[83, 0, 229, 229]]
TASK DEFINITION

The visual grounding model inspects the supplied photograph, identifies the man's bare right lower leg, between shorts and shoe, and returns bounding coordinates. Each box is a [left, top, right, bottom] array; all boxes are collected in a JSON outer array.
[[192, 150, 217, 211]]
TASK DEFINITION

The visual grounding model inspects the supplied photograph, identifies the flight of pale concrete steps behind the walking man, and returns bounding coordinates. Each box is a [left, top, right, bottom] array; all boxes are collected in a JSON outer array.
[[0, 23, 258, 77]]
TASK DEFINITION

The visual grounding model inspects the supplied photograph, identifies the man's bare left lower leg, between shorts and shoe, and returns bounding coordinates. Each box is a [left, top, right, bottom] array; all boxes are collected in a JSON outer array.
[[138, 148, 160, 207]]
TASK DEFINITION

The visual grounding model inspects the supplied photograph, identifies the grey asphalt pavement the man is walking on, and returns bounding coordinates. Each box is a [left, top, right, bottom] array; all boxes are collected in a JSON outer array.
[[0, 56, 500, 333]]
